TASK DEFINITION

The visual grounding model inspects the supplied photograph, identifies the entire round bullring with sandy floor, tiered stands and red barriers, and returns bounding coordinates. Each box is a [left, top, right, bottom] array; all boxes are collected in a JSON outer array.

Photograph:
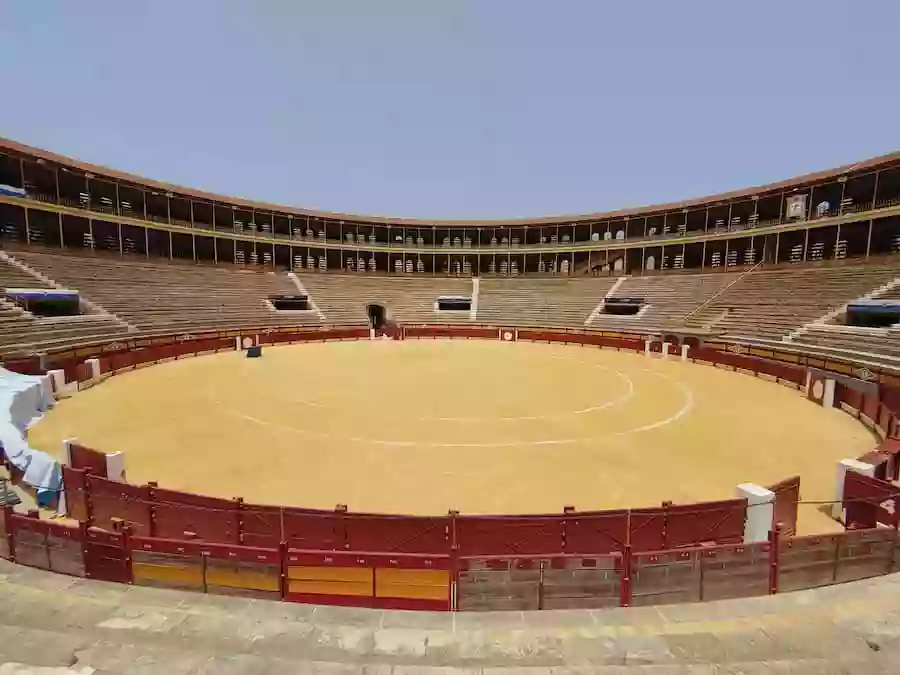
[[0, 141, 900, 673]]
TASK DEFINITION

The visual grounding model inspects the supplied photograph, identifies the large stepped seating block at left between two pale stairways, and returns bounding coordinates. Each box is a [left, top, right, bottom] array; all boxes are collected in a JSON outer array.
[[7, 251, 320, 332]]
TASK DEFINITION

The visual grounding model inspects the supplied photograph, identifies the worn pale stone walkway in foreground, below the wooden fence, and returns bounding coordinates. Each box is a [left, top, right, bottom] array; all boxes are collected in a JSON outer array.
[[0, 561, 900, 675]]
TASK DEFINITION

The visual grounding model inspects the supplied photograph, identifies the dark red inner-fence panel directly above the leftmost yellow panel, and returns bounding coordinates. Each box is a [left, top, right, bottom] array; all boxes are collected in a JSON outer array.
[[150, 485, 240, 544]]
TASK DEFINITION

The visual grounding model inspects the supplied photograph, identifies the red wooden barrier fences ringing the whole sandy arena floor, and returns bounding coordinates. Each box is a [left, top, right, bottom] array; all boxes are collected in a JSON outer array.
[[0, 326, 900, 610]]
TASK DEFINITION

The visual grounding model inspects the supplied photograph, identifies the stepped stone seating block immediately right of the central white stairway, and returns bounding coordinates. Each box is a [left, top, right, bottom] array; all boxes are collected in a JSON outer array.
[[478, 277, 616, 328]]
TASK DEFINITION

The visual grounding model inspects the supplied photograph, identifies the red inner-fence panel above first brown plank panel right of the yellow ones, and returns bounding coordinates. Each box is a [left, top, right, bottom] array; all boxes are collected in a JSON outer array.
[[456, 515, 564, 555]]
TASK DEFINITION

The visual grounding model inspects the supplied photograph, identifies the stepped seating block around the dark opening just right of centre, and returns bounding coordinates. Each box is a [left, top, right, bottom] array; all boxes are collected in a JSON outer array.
[[589, 274, 738, 330]]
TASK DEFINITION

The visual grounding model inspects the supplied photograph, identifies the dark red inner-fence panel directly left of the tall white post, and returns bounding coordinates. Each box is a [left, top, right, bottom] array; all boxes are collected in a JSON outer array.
[[664, 499, 747, 548]]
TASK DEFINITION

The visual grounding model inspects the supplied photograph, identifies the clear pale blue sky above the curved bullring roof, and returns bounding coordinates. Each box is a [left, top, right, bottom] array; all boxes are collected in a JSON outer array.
[[0, 0, 900, 218]]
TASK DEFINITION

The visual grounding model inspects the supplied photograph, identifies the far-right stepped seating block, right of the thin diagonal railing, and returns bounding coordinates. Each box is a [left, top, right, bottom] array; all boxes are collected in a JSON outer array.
[[687, 263, 900, 340]]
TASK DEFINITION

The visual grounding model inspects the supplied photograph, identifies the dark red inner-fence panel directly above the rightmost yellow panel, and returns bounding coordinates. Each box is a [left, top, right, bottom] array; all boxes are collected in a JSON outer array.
[[344, 513, 451, 555]]
